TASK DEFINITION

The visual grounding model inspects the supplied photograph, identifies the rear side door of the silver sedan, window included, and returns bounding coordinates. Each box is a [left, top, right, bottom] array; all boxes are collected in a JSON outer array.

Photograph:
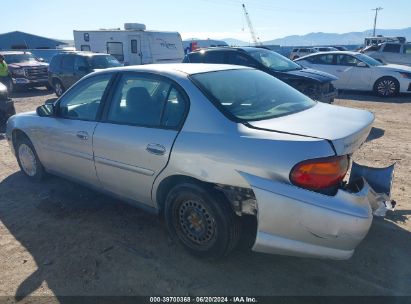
[[93, 73, 188, 205]]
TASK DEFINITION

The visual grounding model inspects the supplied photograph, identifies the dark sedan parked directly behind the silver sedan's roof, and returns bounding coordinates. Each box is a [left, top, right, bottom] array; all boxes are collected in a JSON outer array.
[[183, 47, 338, 103]]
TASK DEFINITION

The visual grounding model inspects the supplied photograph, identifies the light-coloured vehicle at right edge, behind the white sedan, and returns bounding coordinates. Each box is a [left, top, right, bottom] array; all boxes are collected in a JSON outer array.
[[361, 42, 411, 66]]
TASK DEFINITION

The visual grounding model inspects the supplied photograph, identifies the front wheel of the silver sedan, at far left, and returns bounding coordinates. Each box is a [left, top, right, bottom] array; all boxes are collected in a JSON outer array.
[[15, 136, 46, 181]]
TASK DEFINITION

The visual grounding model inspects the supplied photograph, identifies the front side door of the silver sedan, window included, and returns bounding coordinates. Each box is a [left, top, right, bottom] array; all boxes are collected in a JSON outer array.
[[42, 74, 112, 186]]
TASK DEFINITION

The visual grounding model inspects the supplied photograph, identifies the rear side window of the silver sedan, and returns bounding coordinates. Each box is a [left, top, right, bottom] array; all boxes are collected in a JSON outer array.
[[107, 74, 185, 128]]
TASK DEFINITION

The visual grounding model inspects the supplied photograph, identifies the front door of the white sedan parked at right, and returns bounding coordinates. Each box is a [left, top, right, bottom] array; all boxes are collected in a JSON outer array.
[[334, 54, 372, 91]]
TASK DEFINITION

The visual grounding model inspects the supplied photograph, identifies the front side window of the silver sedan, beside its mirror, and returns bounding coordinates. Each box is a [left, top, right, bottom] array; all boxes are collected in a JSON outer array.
[[58, 74, 111, 121]]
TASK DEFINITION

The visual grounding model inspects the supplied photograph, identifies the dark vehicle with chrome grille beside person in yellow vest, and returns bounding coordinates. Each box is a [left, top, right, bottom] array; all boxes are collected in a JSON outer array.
[[0, 51, 51, 92]]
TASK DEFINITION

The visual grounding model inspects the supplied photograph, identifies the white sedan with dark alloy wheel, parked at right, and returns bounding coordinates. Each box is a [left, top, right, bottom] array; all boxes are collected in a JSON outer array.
[[296, 51, 411, 97]]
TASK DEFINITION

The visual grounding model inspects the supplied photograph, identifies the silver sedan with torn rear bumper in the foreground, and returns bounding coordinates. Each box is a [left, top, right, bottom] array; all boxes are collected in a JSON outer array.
[[6, 64, 392, 259]]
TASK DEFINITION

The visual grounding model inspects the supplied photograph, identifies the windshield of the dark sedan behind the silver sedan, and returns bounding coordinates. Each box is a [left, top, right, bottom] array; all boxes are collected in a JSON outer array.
[[247, 49, 301, 72]]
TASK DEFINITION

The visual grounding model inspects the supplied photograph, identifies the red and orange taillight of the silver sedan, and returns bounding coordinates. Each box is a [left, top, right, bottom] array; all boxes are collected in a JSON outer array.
[[290, 155, 349, 190]]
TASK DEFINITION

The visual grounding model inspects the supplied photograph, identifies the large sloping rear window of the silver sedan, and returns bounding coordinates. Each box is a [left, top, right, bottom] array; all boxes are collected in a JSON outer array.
[[191, 69, 315, 122]]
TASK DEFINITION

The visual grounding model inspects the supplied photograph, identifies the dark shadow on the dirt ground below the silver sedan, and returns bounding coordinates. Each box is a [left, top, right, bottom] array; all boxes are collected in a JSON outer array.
[[0, 173, 411, 303]]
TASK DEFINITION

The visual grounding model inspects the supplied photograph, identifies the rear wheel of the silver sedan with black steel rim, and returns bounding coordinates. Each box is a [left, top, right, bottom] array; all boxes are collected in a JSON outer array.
[[164, 183, 241, 259]]
